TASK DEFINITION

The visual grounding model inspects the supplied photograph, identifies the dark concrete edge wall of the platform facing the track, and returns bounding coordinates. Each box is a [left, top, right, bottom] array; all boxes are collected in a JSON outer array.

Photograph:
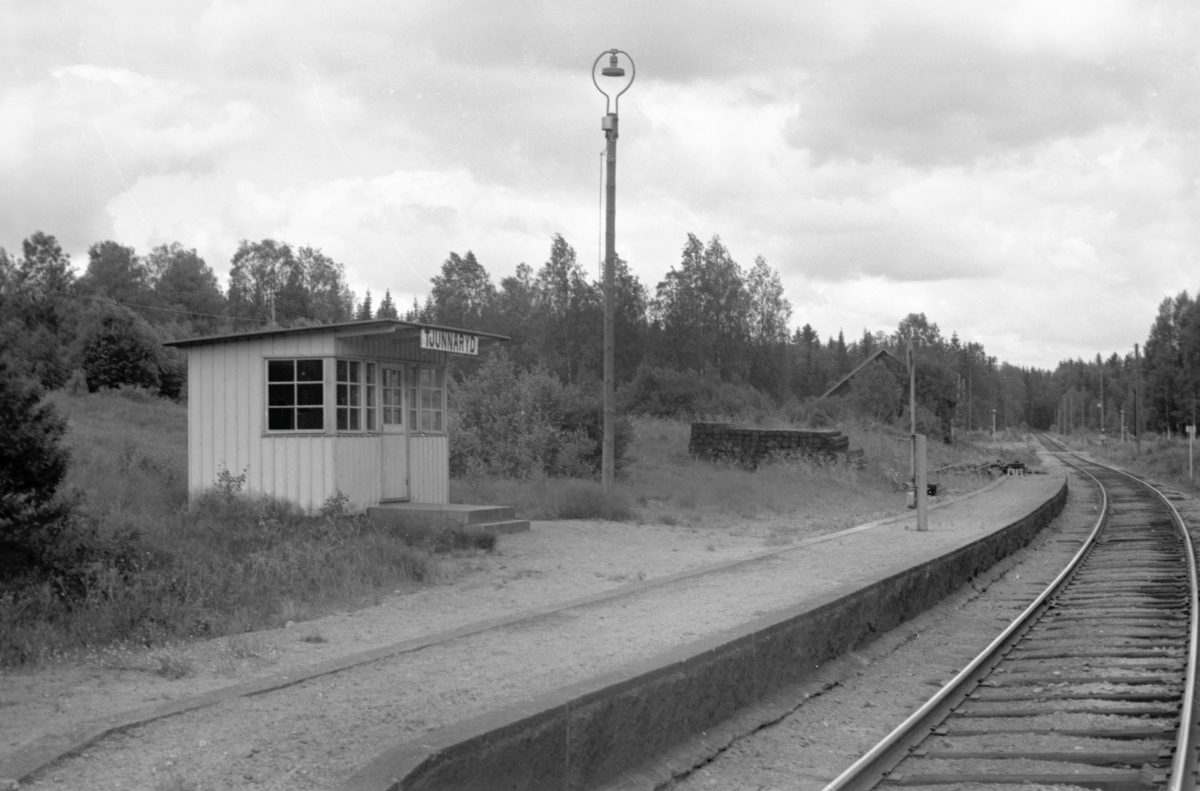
[[347, 480, 1067, 791]]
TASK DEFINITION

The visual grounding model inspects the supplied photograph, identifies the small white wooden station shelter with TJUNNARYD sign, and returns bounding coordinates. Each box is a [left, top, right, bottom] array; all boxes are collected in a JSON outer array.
[[167, 319, 508, 513]]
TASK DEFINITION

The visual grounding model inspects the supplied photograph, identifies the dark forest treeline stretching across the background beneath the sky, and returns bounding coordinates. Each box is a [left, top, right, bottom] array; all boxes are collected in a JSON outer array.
[[0, 232, 1200, 437]]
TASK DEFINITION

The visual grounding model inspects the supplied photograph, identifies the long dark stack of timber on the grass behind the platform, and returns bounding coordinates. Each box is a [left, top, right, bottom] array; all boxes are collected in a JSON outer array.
[[688, 423, 862, 467]]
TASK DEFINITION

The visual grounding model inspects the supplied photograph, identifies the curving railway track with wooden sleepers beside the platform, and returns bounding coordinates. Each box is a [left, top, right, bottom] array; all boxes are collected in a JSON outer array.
[[824, 439, 1200, 791]]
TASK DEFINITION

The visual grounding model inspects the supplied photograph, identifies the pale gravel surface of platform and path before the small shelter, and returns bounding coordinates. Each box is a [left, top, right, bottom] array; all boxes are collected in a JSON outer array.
[[7, 477, 1058, 789]]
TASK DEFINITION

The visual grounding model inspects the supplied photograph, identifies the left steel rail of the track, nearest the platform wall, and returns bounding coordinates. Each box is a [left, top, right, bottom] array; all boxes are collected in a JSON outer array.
[[823, 446, 1108, 791]]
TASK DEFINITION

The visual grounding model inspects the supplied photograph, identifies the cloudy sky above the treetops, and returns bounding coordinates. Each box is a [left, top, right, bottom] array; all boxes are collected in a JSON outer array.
[[0, 0, 1200, 367]]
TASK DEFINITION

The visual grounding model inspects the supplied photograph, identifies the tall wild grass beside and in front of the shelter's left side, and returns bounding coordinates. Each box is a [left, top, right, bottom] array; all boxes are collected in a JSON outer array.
[[0, 394, 458, 665]]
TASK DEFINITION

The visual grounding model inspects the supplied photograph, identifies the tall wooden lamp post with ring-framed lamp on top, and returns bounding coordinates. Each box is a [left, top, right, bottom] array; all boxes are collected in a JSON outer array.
[[592, 49, 637, 495]]
